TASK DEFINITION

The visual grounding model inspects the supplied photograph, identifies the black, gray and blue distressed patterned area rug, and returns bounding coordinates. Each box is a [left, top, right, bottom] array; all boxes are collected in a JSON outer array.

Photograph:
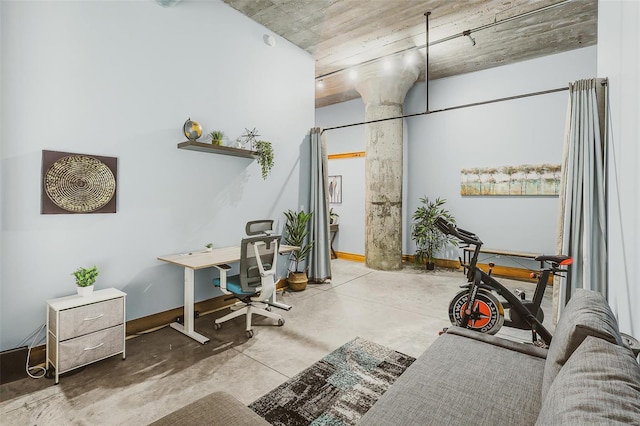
[[249, 337, 415, 426]]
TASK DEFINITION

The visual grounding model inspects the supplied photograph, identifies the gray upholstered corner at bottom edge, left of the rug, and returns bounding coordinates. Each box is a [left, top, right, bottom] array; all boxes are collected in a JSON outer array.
[[151, 391, 269, 426]]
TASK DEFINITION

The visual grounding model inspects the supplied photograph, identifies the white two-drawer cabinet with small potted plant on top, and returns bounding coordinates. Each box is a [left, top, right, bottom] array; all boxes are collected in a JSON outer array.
[[47, 288, 127, 384]]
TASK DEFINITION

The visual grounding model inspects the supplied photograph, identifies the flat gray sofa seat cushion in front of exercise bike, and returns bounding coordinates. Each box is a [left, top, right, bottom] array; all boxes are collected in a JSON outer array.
[[358, 332, 545, 426]]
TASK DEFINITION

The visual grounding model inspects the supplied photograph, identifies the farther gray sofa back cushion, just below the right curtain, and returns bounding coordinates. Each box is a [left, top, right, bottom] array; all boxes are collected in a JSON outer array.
[[542, 289, 622, 400]]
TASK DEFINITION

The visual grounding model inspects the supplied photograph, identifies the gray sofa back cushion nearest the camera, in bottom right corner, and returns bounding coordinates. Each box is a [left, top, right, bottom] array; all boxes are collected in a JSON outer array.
[[536, 336, 640, 425]]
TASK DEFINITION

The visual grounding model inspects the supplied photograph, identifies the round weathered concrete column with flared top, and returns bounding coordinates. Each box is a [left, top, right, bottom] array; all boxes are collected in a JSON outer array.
[[356, 58, 419, 271]]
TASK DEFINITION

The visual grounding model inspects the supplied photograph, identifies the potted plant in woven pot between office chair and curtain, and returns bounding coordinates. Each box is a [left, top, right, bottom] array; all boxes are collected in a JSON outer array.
[[284, 210, 314, 291]]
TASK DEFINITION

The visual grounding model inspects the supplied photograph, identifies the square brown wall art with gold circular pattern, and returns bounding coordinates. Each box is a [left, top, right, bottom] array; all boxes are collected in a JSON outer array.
[[40, 150, 118, 214]]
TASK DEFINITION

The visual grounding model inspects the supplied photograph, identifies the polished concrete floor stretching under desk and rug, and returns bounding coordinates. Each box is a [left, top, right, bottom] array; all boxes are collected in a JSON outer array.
[[0, 259, 552, 425]]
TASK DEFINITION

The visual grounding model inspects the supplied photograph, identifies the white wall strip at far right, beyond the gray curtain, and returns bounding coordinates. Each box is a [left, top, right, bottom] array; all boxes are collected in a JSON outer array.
[[598, 0, 640, 337]]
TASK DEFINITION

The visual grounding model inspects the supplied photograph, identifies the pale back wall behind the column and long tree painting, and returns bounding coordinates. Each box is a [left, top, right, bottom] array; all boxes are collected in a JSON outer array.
[[316, 47, 596, 266]]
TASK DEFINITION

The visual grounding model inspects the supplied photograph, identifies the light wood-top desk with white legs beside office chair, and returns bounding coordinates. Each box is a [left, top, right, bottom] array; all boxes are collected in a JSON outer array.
[[158, 245, 298, 344]]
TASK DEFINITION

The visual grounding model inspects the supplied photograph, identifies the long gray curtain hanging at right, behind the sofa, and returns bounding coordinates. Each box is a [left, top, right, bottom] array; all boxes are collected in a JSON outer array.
[[554, 79, 607, 318]]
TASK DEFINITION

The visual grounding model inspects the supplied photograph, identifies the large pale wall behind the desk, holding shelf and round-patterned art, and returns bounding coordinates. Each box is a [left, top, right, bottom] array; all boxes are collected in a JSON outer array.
[[0, 0, 314, 349]]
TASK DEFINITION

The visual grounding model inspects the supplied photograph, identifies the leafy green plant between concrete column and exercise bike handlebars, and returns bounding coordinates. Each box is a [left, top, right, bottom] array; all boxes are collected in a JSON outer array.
[[411, 197, 458, 271]]
